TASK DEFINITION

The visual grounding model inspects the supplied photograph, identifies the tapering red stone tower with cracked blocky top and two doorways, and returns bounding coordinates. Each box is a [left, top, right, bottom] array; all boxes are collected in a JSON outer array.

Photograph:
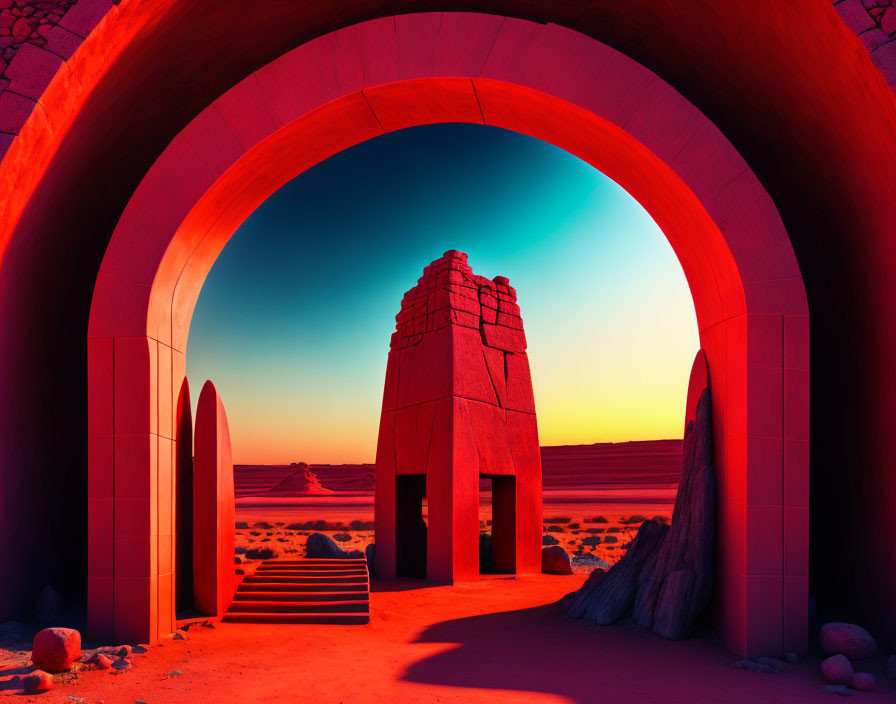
[[376, 250, 542, 583]]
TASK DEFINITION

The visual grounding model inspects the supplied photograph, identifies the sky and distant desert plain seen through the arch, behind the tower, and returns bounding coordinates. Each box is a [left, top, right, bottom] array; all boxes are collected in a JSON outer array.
[[184, 124, 699, 576]]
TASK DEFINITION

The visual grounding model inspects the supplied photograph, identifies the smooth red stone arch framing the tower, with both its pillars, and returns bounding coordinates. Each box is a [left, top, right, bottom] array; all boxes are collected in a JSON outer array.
[[88, 13, 809, 654]]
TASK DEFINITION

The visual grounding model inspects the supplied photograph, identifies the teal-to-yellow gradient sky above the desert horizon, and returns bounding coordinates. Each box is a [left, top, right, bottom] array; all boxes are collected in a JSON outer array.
[[187, 125, 698, 464]]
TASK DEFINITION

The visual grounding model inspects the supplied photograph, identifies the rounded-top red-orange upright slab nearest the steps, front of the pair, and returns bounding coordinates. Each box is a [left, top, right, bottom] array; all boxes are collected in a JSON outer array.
[[193, 381, 235, 616]]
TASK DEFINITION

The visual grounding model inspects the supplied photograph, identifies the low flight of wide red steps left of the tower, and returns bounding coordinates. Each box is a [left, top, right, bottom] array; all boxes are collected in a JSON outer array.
[[223, 558, 370, 624]]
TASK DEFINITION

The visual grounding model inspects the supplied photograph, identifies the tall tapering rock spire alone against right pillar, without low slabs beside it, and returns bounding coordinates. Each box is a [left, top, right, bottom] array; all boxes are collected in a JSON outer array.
[[633, 352, 716, 640]]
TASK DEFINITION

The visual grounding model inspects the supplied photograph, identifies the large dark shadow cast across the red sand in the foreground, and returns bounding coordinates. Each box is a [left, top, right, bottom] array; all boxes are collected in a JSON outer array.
[[402, 603, 792, 703]]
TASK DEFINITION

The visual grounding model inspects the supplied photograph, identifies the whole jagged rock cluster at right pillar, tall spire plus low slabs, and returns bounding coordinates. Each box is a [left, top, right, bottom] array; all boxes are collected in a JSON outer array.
[[568, 350, 716, 639]]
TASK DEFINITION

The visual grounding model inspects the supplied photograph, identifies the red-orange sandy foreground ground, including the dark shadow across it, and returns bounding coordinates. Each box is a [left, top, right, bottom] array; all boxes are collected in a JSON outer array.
[[0, 575, 896, 704]]
